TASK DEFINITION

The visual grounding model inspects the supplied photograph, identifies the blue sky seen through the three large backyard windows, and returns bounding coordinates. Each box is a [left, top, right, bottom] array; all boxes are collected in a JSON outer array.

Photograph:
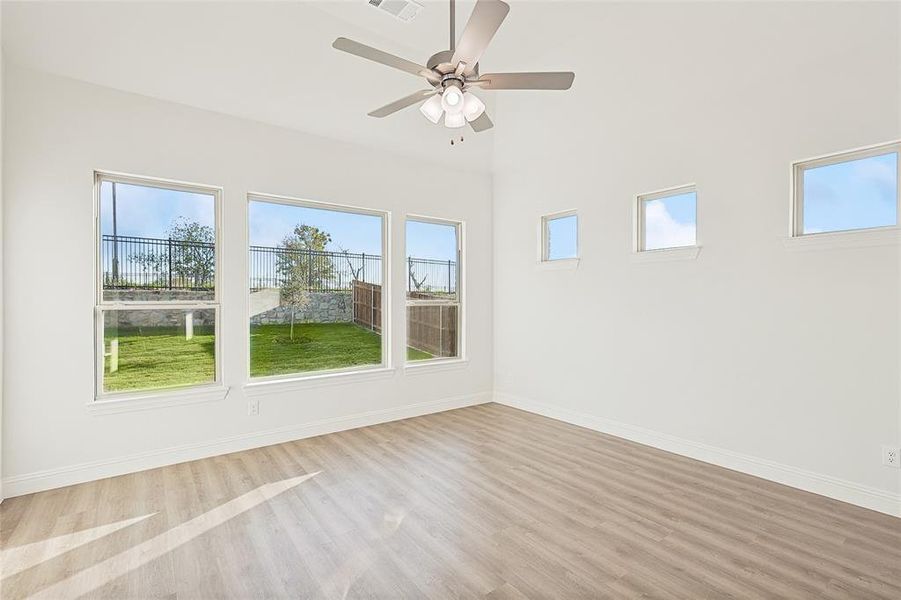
[[100, 182, 457, 260]]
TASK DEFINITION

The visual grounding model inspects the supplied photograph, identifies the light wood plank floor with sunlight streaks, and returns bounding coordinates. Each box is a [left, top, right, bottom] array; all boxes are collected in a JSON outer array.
[[0, 404, 901, 600]]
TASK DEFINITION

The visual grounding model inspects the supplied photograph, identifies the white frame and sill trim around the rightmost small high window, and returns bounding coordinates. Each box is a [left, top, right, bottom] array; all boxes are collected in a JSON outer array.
[[786, 140, 901, 250]]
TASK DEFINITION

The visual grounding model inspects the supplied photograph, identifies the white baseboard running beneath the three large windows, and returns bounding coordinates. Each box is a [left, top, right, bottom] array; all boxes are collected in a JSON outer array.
[[2, 392, 491, 498]]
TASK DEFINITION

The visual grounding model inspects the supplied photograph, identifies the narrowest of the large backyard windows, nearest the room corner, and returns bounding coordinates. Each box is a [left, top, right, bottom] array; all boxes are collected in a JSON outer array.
[[406, 217, 463, 362]]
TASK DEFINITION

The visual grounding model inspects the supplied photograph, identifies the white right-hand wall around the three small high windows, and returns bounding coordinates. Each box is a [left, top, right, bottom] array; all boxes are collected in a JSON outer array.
[[492, 2, 901, 514]]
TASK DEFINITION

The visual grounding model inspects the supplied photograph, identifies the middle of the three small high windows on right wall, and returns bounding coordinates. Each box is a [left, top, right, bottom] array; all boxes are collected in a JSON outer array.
[[635, 185, 698, 252]]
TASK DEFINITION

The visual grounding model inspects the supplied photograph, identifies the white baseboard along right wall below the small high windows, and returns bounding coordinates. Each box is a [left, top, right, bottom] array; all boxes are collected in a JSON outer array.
[[494, 392, 901, 517]]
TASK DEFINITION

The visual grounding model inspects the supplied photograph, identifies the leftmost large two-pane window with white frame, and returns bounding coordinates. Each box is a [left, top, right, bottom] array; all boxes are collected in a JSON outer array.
[[95, 173, 220, 398]]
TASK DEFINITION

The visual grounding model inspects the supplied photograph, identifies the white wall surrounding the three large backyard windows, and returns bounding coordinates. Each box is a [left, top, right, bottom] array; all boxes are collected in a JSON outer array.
[[3, 64, 492, 496]]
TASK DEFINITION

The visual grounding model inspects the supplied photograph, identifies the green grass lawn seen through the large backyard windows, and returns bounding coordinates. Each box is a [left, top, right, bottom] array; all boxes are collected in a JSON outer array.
[[104, 323, 432, 392]]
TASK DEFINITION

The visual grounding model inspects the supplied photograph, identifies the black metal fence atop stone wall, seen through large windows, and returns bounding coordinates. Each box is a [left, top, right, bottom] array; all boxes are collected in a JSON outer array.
[[101, 235, 457, 294]]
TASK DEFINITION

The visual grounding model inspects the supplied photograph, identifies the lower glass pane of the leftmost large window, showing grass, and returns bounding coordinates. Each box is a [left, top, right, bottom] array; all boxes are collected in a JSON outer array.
[[103, 309, 216, 392]]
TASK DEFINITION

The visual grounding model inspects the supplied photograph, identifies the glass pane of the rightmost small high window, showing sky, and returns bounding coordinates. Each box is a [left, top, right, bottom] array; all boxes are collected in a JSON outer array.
[[803, 152, 898, 233]]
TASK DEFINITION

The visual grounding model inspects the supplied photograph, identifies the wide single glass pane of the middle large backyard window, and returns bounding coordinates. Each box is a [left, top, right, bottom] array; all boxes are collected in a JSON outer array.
[[249, 200, 382, 377]]
